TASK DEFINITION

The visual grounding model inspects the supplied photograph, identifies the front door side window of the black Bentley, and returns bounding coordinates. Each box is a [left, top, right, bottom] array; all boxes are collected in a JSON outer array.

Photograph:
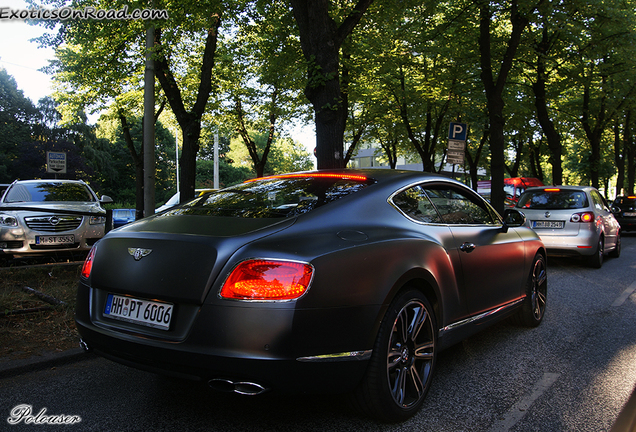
[[424, 185, 498, 225]]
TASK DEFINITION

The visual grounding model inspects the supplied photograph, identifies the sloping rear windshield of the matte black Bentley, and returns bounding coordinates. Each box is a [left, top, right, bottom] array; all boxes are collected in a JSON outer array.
[[165, 177, 373, 218]]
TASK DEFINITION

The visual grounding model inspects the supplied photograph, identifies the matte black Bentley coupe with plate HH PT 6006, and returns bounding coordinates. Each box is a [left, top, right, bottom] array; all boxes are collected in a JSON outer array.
[[76, 170, 547, 421]]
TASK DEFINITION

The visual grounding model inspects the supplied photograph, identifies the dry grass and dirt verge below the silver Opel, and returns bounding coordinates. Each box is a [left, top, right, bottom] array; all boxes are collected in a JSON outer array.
[[0, 264, 81, 359]]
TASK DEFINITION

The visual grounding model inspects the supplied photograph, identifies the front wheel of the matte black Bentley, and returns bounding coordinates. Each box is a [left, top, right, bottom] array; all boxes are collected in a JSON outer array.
[[515, 253, 548, 327]]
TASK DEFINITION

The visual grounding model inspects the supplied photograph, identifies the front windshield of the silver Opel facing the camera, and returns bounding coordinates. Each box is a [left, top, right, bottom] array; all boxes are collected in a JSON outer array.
[[5, 182, 95, 203]]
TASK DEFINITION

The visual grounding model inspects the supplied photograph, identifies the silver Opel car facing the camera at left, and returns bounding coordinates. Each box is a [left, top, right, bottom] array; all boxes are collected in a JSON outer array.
[[0, 180, 112, 258]]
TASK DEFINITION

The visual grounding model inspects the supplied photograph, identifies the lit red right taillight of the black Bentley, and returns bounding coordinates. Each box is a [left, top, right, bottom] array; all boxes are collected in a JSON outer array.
[[220, 260, 314, 300]]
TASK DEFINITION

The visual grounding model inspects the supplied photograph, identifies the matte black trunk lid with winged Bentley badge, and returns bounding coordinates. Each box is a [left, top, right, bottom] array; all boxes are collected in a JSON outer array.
[[91, 215, 295, 304]]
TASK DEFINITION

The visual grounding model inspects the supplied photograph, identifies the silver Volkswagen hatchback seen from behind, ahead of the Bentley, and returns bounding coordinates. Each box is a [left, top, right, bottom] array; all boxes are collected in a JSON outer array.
[[516, 186, 621, 268]]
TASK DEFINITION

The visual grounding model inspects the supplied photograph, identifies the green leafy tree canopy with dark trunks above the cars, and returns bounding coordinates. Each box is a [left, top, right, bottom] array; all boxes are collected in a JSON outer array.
[[0, 0, 636, 210]]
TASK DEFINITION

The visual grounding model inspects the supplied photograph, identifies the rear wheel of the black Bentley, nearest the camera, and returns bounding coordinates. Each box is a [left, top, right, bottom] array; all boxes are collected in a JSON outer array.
[[353, 289, 437, 423]]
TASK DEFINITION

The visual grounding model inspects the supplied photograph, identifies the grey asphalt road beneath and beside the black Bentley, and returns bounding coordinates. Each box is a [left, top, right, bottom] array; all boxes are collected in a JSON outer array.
[[0, 234, 636, 432]]
